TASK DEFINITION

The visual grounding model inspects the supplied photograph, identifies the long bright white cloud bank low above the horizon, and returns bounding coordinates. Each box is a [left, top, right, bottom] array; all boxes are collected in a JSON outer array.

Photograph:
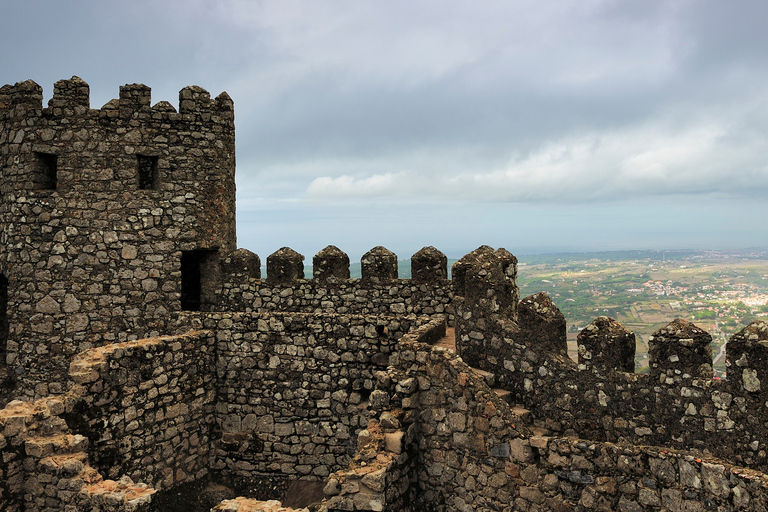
[[306, 117, 768, 202]]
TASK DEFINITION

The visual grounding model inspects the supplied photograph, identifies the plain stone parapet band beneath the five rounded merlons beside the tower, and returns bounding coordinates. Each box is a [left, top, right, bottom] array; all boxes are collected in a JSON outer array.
[[215, 280, 453, 324]]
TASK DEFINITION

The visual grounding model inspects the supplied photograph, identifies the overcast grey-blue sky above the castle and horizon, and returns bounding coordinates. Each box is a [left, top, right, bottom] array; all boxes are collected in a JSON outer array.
[[0, 0, 768, 263]]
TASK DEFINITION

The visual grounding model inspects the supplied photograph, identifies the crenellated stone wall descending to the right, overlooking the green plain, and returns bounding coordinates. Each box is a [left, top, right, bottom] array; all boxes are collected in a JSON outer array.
[[456, 246, 768, 471]]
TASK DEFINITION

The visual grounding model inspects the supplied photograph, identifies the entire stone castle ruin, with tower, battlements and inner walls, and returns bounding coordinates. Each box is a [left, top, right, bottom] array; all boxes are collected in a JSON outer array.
[[0, 77, 768, 512]]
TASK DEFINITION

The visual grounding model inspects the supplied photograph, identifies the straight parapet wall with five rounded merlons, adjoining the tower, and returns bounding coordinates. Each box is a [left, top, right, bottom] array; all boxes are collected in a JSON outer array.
[[210, 246, 453, 324]]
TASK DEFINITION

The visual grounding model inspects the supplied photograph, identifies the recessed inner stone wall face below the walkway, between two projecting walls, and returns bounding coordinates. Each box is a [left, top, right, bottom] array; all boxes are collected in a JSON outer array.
[[186, 313, 428, 486]]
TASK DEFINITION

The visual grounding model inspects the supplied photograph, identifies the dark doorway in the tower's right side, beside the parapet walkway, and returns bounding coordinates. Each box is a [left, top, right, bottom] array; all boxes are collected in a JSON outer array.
[[181, 249, 219, 311]]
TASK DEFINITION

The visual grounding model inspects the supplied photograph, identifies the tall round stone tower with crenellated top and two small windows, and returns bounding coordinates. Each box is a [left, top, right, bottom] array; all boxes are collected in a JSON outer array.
[[0, 77, 236, 396]]
